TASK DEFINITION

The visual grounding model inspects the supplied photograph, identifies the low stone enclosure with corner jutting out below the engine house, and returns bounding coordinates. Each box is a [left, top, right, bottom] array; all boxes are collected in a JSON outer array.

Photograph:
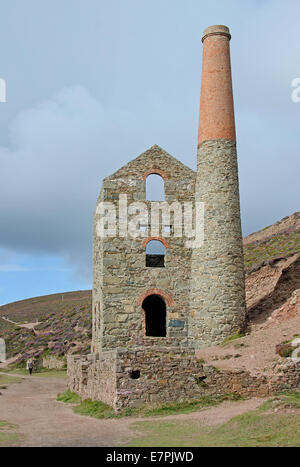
[[68, 347, 203, 411]]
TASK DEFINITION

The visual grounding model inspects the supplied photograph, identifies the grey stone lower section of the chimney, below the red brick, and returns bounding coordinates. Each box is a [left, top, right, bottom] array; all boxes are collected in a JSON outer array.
[[189, 139, 245, 348]]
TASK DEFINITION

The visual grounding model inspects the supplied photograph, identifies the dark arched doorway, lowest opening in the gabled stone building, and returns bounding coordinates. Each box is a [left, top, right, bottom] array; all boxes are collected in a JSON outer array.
[[142, 295, 167, 337]]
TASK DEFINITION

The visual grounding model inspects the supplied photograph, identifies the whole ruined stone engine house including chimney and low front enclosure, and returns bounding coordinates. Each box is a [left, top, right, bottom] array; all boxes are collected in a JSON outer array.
[[68, 26, 245, 411]]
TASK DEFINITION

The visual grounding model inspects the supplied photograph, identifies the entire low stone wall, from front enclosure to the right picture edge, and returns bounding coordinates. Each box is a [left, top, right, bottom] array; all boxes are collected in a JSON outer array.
[[68, 347, 300, 412]]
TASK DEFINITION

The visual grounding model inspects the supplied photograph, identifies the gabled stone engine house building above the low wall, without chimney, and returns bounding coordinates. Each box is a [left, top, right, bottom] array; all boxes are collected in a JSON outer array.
[[92, 146, 195, 352]]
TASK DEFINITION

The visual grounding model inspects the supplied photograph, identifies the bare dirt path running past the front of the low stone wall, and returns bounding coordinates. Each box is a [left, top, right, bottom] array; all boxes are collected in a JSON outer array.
[[0, 375, 263, 446]]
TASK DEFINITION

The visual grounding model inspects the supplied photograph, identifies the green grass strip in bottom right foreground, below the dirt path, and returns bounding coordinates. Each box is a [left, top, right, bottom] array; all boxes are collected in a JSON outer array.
[[128, 411, 300, 447]]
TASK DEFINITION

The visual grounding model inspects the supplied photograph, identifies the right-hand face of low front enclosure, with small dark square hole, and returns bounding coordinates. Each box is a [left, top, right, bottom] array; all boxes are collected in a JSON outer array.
[[116, 347, 203, 410]]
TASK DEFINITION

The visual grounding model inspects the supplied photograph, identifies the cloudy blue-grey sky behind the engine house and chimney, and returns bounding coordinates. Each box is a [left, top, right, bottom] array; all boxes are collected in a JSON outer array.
[[0, 0, 300, 304]]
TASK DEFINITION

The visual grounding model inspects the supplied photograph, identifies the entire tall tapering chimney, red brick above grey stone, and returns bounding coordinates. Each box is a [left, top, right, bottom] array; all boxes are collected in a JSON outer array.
[[189, 26, 245, 348]]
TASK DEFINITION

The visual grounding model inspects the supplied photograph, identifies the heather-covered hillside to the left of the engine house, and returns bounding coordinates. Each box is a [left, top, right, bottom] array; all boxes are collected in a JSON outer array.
[[0, 290, 92, 363]]
